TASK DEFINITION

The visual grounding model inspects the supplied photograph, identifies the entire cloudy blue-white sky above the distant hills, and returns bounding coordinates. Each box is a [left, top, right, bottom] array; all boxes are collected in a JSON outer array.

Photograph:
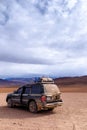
[[0, 0, 87, 77]]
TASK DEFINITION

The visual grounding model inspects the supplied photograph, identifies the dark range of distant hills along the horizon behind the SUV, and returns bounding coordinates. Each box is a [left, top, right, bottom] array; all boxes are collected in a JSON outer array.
[[0, 76, 87, 87]]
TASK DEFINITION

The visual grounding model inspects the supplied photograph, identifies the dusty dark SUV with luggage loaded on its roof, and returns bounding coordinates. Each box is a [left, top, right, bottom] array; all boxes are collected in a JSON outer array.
[[6, 78, 62, 113]]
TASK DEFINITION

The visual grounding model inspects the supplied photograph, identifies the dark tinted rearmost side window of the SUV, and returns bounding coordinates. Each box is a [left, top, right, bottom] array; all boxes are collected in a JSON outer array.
[[31, 85, 43, 94]]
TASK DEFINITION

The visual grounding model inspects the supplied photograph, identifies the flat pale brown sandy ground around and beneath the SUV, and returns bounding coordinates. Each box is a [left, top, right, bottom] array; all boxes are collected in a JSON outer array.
[[0, 93, 87, 130]]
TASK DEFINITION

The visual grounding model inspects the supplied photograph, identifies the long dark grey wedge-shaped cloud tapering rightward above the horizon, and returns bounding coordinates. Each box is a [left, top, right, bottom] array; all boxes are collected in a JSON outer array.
[[0, 48, 53, 64]]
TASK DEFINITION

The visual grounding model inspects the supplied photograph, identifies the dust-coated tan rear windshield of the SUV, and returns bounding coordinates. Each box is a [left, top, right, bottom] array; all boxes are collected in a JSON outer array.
[[44, 84, 60, 93]]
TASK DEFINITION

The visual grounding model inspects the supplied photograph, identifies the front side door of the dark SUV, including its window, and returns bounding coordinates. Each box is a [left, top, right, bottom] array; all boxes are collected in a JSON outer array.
[[12, 87, 24, 104]]
